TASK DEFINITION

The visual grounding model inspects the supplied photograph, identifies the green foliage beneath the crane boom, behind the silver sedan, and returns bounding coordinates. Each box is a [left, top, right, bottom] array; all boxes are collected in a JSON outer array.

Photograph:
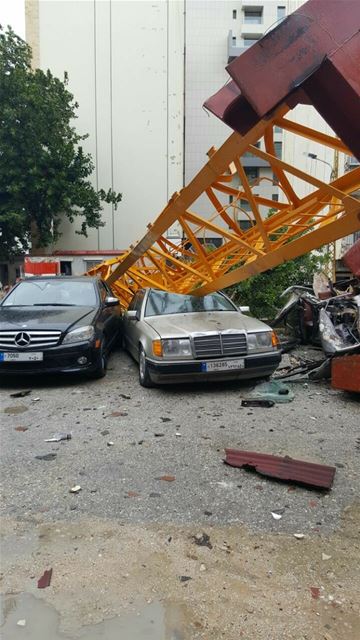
[[226, 253, 328, 320]]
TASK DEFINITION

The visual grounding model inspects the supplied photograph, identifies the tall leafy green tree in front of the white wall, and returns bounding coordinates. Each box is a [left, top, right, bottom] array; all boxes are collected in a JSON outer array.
[[0, 26, 121, 259]]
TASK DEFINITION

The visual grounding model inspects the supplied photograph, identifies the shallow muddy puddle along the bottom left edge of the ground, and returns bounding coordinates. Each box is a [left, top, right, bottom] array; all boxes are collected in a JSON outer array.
[[0, 593, 190, 640]]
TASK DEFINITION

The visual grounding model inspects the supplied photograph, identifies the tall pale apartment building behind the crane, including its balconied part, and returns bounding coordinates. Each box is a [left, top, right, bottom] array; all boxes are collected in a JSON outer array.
[[22, 0, 348, 273]]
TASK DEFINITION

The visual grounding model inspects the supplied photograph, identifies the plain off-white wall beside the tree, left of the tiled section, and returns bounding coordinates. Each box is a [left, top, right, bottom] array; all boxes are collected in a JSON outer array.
[[27, 0, 184, 250]]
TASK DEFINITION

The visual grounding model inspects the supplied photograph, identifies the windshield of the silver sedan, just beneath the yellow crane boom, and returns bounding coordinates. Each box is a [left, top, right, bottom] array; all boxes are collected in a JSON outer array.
[[145, 291, 236, 317]]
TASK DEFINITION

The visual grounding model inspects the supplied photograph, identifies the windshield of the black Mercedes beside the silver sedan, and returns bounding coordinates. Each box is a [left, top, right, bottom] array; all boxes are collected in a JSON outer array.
[[3, 279, 96, 307]]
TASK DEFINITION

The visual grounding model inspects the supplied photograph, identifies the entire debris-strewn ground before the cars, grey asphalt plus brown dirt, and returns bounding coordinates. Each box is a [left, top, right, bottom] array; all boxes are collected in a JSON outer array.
[[0, 351, 360, 640]]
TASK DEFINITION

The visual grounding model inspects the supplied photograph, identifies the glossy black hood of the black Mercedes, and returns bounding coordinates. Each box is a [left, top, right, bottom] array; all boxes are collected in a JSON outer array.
[[0, 306, 96, 331]]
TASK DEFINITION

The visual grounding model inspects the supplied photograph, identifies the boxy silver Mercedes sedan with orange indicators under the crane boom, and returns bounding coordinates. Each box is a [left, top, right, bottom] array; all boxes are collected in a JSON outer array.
[[122, 289, 281, 387]]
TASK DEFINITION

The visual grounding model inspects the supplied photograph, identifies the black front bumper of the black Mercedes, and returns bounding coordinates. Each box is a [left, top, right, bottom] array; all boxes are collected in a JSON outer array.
[[0, 342, 100, 375]]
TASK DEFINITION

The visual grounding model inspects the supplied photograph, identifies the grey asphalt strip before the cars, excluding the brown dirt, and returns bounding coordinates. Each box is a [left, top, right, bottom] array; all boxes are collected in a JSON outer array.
[[0, 350, 360, 533]]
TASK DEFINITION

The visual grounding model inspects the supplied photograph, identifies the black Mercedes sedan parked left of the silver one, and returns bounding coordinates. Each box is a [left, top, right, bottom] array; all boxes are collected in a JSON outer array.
[[0, 276, 120, 378]]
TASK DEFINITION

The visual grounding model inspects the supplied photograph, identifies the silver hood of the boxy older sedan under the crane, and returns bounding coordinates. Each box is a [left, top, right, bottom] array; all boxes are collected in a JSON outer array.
[[145, 311, 270, 338]]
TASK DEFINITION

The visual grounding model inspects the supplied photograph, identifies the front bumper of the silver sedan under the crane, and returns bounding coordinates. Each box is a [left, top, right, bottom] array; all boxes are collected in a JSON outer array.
[[146, 351, 281, 384]]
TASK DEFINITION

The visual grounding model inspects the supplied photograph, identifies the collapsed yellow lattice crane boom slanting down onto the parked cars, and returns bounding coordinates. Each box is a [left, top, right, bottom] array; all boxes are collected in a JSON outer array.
[[89, 0, 360, 307]]
